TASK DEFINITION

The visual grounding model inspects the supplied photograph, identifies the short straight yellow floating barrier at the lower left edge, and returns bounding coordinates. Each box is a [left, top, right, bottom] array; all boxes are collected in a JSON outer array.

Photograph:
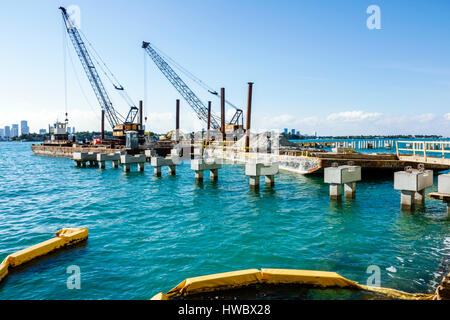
[[0, 228, 88, 281]]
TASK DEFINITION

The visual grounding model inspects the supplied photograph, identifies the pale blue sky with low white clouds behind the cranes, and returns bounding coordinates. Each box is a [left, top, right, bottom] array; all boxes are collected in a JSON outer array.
[[0, 0, 450, 136]]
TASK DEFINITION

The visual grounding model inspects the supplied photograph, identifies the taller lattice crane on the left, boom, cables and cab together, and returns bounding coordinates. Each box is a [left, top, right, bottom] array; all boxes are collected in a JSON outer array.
[[59, 7, 144, 142]]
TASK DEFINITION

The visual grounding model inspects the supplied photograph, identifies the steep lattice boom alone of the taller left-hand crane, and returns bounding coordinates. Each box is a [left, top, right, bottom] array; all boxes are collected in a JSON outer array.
[[59, 7, 121, 129]]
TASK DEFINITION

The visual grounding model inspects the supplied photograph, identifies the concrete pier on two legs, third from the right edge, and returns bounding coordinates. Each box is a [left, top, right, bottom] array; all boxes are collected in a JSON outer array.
[[324, 165, 361, 200]]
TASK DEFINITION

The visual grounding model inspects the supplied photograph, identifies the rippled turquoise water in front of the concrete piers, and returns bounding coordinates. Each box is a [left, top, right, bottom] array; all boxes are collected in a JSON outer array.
[[0, 143, 450, 299]]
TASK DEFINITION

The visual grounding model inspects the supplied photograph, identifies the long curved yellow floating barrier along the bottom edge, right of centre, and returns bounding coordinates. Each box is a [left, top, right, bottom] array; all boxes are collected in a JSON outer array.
[[151, 269, 435, 300]]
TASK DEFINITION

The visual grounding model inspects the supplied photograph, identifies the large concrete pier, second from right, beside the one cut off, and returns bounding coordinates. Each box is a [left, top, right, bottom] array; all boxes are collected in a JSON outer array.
[[394, 169, 433, 210]]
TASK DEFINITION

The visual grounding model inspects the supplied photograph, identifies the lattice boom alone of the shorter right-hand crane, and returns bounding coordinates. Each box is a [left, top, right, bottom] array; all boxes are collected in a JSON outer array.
[[142, 41, 220, 129]]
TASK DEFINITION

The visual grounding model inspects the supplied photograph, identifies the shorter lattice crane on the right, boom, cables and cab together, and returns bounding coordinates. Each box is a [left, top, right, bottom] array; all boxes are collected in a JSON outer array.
[[142, 41, 244, 131]]
